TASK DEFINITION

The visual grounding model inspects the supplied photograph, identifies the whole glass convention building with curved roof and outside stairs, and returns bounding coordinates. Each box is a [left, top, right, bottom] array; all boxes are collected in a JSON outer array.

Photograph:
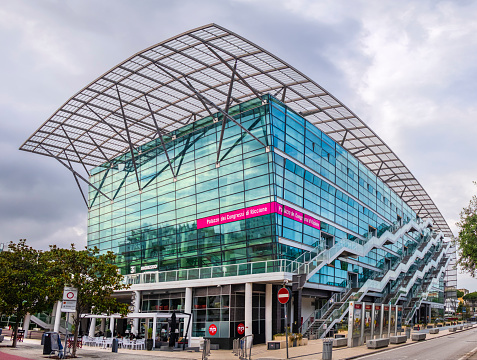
[[22, 25, 456, 347]]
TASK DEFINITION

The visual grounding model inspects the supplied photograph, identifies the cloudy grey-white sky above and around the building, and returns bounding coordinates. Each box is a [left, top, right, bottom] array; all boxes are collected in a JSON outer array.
[[0, 0, 477, 291]]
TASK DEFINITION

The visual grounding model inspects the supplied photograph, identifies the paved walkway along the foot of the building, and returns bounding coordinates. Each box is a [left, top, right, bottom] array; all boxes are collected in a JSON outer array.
[[0, 328, 470, 360]]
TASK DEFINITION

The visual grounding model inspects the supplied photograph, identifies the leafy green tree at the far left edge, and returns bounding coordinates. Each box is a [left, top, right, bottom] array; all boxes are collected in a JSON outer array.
[[0, 239, 61, 347]]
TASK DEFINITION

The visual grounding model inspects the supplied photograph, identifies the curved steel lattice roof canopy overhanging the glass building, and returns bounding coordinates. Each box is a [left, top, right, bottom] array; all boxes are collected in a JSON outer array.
[[20, 24, 452, 236]]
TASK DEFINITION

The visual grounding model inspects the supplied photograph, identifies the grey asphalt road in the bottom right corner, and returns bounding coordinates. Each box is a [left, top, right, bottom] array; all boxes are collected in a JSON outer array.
[[359, 329, 477, 360]]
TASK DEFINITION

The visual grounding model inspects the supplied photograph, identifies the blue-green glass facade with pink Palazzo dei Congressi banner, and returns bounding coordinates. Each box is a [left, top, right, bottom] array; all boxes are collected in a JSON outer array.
[[88, 95, 438, 287]]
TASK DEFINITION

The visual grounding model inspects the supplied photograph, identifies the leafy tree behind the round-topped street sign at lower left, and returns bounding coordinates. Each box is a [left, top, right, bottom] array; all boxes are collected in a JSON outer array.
[[49, 244, 129, 357]]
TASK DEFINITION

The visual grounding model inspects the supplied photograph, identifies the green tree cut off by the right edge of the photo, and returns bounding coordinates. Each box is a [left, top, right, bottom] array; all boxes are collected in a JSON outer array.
[[456, 181, 477, 277]]
